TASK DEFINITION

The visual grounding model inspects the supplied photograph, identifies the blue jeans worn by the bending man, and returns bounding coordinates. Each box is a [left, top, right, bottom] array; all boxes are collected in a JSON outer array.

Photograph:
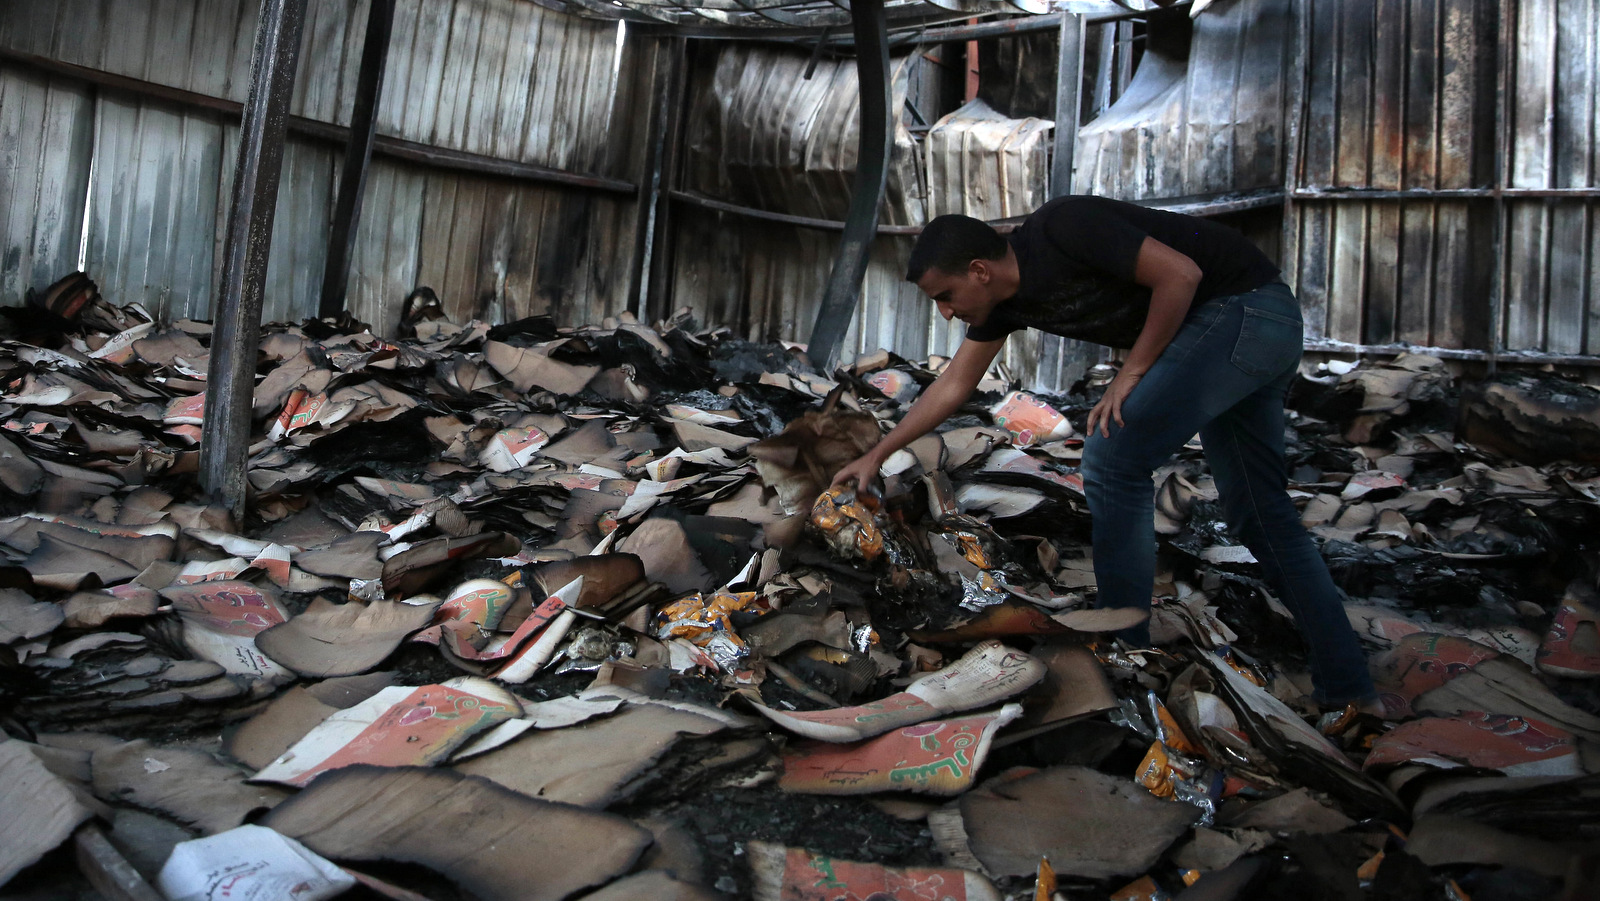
[[1083, 282, 1376, 704]]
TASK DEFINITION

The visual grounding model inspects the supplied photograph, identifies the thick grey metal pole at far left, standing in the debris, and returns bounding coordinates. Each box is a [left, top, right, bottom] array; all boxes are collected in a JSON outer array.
[[200, 0, 306, 522]]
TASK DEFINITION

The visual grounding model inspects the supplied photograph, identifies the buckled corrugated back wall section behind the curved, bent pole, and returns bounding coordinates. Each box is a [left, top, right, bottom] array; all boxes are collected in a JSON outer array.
[[672, 45, 962, 368]]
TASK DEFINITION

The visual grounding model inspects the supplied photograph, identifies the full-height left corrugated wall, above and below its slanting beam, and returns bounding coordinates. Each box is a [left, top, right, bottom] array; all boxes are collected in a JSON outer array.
[[0, 0, 636, 330]]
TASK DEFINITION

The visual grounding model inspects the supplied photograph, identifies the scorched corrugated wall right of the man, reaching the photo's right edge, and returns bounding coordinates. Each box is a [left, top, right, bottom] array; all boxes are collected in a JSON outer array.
[[1288, 0, 1600, 355]]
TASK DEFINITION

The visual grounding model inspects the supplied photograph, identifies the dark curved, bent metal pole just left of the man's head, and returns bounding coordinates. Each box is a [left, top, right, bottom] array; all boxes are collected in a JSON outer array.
[[806, 0, 894, 373]]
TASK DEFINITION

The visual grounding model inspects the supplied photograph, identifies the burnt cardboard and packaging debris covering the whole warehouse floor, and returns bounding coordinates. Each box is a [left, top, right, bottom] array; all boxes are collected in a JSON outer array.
[[0, 277, 1600, 901]]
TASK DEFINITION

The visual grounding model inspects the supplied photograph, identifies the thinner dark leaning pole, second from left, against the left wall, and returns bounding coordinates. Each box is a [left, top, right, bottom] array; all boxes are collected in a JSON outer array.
[[317, 0, 395, 317]]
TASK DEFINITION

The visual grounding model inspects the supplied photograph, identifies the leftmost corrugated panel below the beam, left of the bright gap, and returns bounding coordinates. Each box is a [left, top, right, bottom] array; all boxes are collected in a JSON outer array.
[[0, 66, 94, 307]]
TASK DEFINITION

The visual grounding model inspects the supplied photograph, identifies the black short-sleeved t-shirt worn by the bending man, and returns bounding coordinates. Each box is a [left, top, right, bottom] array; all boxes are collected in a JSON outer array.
[[966, 197, 1278, 347]]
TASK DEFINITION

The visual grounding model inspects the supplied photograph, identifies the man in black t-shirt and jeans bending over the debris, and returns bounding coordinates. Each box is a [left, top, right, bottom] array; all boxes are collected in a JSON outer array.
[[834, 197, 1376, 711]]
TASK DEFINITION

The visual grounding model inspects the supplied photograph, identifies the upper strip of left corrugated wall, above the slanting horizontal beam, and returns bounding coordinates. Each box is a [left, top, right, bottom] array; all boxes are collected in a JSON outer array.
[[0, 0, 618, 171]]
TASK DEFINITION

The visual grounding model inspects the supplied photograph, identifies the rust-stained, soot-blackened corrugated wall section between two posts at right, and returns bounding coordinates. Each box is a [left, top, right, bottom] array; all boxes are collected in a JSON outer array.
[[1290, 0, 1498, 349]]
